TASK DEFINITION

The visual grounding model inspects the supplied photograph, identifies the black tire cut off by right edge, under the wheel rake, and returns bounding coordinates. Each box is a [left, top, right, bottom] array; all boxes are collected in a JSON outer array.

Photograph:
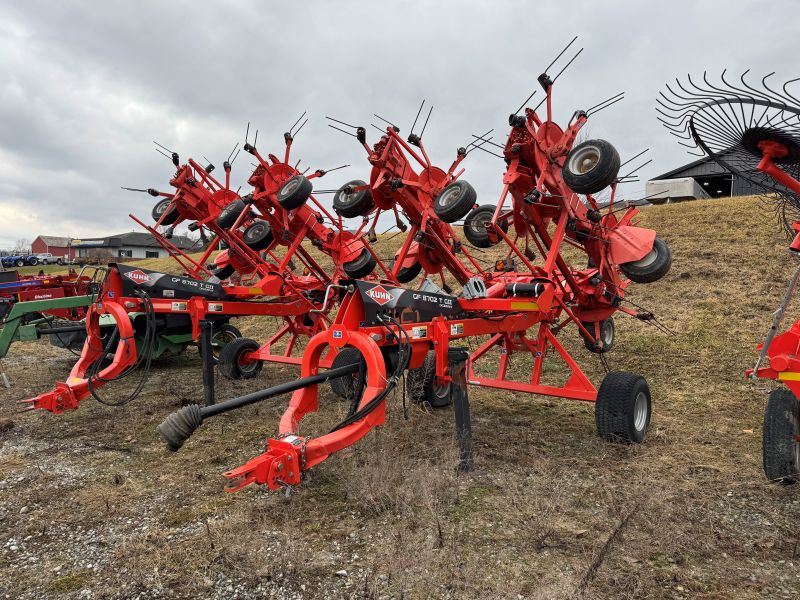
[[762, 388, 800, 484]]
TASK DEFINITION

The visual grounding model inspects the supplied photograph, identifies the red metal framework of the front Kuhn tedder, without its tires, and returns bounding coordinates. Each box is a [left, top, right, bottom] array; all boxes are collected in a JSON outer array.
[[214, 75, 668, 491]]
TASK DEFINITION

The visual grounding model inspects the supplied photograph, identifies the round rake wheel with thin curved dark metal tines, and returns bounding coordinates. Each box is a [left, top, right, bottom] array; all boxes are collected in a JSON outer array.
[[656, 71, 800, 230]]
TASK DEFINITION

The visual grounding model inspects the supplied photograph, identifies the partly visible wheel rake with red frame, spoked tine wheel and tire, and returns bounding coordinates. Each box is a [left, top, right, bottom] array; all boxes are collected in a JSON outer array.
[[657, 71, 800, 483]]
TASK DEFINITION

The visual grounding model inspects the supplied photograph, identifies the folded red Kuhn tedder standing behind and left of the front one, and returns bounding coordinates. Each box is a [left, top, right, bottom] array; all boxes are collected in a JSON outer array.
[[25, 121, 384, 413]]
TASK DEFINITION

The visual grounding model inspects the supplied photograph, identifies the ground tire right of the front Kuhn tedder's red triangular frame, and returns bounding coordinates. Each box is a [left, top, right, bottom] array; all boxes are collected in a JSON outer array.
[[594, 371, 651, 444]]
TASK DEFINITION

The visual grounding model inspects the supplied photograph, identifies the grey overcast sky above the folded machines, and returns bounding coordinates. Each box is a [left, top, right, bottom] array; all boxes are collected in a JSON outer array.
[[0, 0, 800, 248]]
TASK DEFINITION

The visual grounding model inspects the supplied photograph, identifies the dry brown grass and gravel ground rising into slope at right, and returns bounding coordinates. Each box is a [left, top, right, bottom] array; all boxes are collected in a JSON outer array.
[[0, 198, 800, 599]]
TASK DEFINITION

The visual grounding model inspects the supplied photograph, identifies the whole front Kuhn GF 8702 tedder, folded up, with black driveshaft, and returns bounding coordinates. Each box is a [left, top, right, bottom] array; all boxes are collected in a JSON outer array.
[[158, 40, 671, 490]]
